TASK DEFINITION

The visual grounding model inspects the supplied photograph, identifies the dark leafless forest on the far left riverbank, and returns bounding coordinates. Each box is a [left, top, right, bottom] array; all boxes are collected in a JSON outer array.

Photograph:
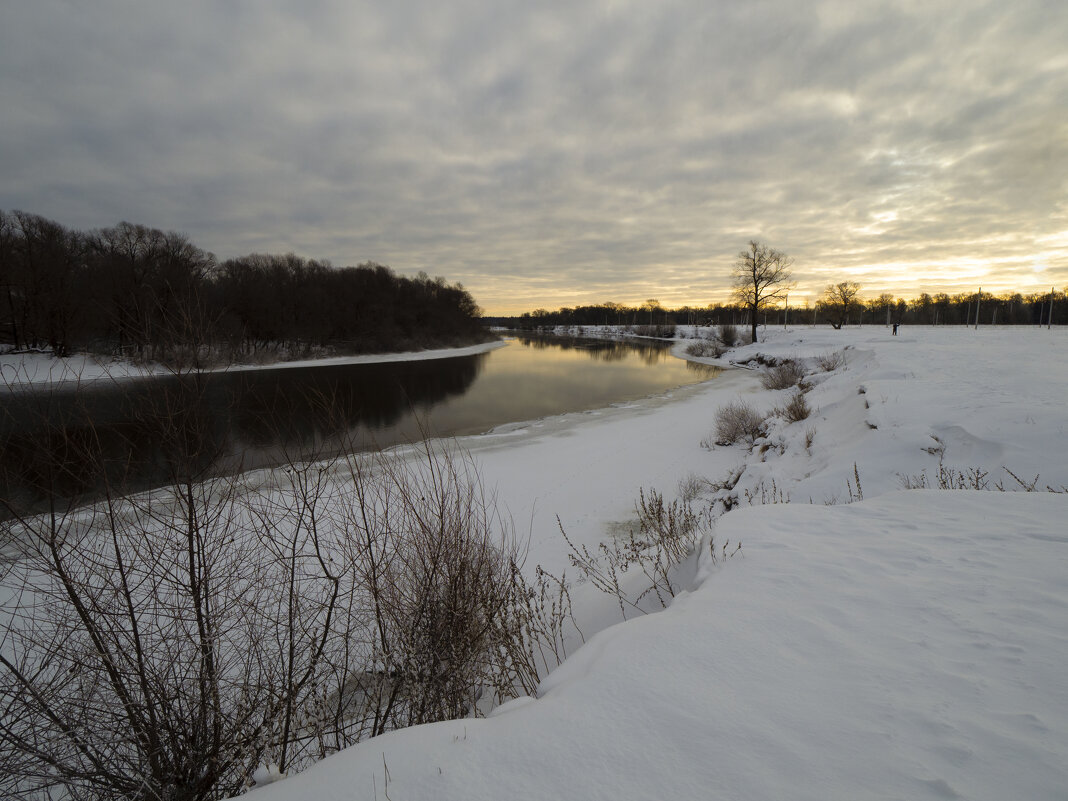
[[0, 210, 487, 363]]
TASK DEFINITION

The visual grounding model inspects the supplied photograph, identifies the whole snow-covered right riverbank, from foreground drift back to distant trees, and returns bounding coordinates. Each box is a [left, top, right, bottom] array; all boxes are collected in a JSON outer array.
[[242, 328, 1068, 801]]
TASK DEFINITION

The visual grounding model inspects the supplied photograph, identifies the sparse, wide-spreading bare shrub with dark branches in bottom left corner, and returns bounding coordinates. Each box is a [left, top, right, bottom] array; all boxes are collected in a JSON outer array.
[[0, 469, 344, 799]]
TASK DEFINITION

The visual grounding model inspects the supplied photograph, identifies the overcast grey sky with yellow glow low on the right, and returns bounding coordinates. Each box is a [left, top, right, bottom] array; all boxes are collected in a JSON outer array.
[[0, 0, 1068, 313]]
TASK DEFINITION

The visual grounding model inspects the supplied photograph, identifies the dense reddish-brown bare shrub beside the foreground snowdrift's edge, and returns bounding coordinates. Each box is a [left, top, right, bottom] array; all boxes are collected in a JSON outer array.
[[345, 444, 522, 734]]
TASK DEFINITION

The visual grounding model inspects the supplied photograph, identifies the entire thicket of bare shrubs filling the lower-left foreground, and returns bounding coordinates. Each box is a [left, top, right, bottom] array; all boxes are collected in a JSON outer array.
[[0, 380, 525, 801]]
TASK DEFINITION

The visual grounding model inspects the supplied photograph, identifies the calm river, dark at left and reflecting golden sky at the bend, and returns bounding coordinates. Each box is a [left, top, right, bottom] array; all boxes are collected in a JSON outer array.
[[0, 337, 717, 508]]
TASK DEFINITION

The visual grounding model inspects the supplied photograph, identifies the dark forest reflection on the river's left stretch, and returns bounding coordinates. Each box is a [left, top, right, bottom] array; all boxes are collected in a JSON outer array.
[[0, 354, 487, 509]]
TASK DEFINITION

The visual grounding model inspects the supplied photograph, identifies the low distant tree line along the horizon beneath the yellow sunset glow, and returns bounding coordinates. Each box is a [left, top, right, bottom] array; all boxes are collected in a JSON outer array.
[[484, 292, 1068, 335]]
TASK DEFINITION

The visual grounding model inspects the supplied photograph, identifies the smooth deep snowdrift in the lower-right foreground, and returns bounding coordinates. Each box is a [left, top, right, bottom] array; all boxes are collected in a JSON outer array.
[[244, 491, 1068, 801]]
